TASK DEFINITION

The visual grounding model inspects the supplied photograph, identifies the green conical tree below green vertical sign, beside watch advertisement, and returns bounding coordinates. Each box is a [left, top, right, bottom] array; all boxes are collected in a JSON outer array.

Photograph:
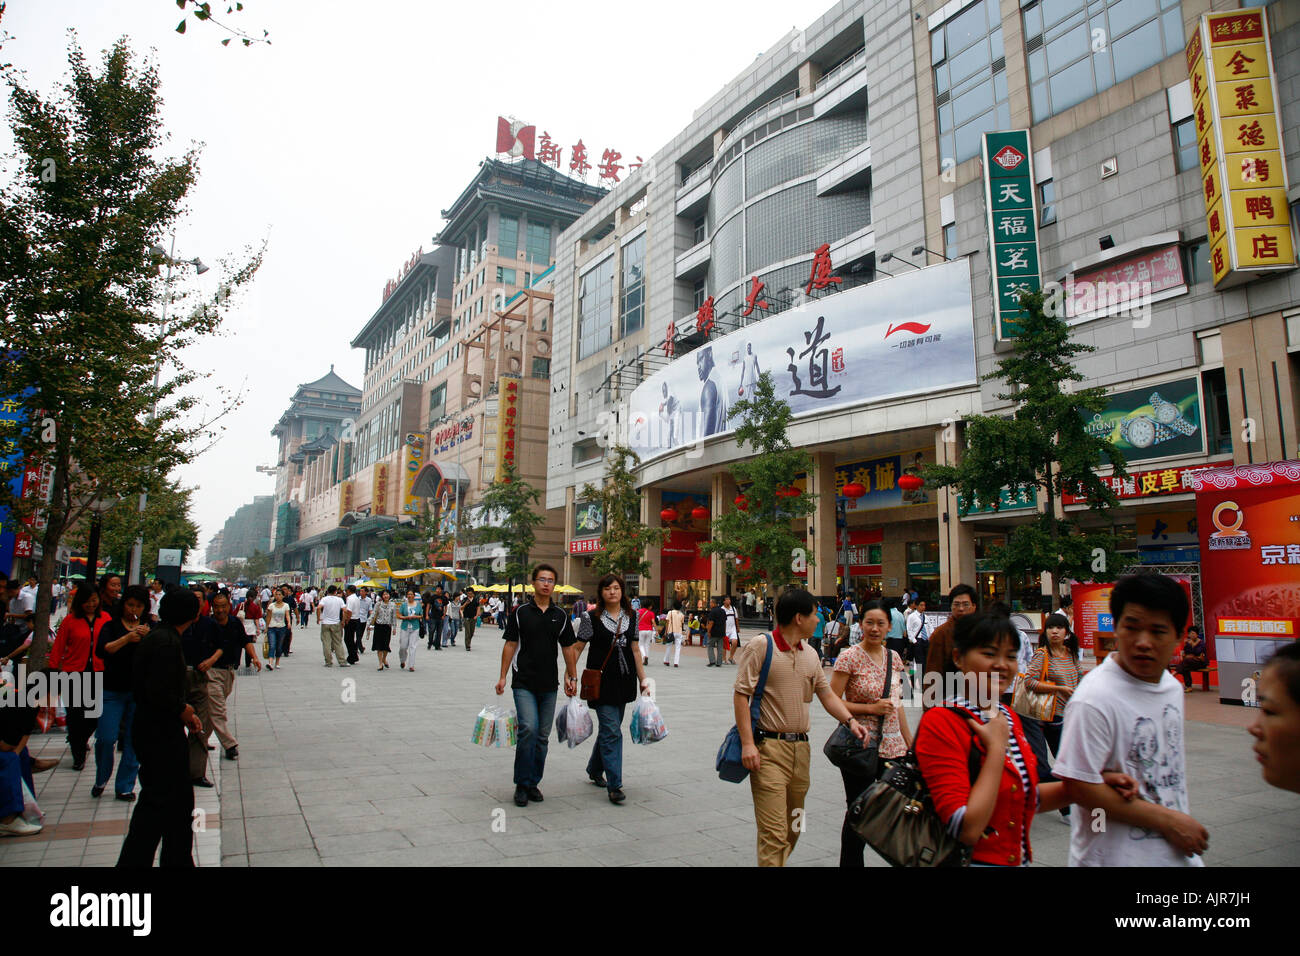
[[924, 293, 1130, 594]]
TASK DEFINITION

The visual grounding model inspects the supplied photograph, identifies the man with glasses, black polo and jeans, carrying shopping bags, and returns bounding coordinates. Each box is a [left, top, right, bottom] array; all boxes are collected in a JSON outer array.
[[497, 564, 579, 806]]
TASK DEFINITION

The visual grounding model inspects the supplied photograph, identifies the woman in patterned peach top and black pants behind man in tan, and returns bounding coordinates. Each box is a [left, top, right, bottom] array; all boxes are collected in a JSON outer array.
[[831, 601, 911, 868]]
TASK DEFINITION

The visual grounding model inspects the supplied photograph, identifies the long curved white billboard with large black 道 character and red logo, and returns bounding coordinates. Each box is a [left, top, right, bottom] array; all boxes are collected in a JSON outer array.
[[628, 259, 976, 460]]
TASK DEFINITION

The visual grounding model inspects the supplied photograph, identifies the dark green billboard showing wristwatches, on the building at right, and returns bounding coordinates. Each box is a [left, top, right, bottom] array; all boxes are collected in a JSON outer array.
[[1083, 377, 1205, 464]]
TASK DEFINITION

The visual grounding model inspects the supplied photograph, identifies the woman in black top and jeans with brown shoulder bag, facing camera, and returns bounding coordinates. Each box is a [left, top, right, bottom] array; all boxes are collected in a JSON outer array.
[[577, 575, 650, 804]]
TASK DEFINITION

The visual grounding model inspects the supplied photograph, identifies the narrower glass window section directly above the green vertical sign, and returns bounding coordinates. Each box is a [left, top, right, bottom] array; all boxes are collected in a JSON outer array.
[[930, 0, 1011, 164]]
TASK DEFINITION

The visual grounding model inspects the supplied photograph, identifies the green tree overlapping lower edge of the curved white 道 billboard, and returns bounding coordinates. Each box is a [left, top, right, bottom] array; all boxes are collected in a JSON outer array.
[[699, 372, 816, 594]]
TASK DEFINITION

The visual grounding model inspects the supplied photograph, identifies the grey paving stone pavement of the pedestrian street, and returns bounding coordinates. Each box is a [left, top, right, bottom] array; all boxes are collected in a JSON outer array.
[[205, 626, 1300, 866]]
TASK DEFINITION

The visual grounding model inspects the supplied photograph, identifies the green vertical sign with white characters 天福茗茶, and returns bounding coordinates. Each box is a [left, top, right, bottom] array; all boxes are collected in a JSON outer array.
[[983, 130, 1043, 339]]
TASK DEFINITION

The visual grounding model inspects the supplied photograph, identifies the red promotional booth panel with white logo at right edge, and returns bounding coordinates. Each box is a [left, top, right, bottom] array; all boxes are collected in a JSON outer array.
[[1196, 462, 1300, 706]]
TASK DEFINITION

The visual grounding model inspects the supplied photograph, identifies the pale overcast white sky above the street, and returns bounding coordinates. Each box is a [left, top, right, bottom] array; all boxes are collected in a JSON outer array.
[[0, 0, 811, 554]]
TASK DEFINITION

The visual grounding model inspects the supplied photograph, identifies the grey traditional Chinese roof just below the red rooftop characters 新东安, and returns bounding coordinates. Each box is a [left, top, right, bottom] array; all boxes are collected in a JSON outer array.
[[434, 159, 608, 246]]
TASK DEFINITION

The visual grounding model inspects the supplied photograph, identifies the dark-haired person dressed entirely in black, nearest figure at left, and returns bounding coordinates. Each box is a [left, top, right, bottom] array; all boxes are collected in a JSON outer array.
[[117, 589, 205, 868]]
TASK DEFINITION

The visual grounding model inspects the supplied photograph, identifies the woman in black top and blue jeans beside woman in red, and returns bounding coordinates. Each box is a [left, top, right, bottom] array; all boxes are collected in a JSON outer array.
[[90, 584, 151, 800]]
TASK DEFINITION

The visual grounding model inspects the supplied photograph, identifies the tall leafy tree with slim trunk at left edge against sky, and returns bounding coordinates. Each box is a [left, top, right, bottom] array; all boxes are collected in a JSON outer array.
[[0, 40, 261, 665]]
